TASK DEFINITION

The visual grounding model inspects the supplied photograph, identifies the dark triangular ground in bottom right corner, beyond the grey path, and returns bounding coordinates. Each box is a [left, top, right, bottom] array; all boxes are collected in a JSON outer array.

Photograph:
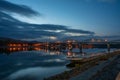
[[90, 52, 120, 80]]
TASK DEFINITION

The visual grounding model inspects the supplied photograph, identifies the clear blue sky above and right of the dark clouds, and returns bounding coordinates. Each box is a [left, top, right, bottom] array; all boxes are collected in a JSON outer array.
[[8, 0, 120, 36]]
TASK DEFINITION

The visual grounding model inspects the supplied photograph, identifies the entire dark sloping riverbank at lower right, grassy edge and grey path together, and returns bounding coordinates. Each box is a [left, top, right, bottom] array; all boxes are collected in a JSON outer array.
[[45, 51, 120, 80]]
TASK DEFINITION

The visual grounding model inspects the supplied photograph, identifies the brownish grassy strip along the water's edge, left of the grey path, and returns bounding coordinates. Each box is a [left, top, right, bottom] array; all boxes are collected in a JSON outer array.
[[44, 50, 120, 80]]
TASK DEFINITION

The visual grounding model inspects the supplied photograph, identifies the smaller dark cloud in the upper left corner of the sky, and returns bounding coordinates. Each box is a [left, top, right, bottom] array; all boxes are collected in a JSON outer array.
[[0, 0, 39, 16]]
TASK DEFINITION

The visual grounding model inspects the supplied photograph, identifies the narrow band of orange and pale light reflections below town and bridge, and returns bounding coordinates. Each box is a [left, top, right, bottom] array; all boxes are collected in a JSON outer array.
[[0, 44, 115, 57]]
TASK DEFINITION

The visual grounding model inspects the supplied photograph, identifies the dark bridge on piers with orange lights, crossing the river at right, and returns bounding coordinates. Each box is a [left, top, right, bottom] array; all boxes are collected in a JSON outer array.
[[43, 41, 120, 53]]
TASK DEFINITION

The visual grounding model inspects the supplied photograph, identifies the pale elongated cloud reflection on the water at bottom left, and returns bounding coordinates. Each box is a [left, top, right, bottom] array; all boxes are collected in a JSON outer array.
[[5, 67, 66, 80]]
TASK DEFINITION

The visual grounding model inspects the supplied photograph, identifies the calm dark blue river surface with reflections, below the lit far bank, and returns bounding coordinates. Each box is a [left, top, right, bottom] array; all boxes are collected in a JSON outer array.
[[0, 48, 115, 80]]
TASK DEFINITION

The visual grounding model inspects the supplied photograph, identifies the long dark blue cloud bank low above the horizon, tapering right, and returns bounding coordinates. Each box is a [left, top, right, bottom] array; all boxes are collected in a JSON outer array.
[[0, 12, 94, 41]]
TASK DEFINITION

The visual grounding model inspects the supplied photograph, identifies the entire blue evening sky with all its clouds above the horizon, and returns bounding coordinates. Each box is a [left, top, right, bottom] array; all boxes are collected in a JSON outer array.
[[0, 0, 120, 41]]
